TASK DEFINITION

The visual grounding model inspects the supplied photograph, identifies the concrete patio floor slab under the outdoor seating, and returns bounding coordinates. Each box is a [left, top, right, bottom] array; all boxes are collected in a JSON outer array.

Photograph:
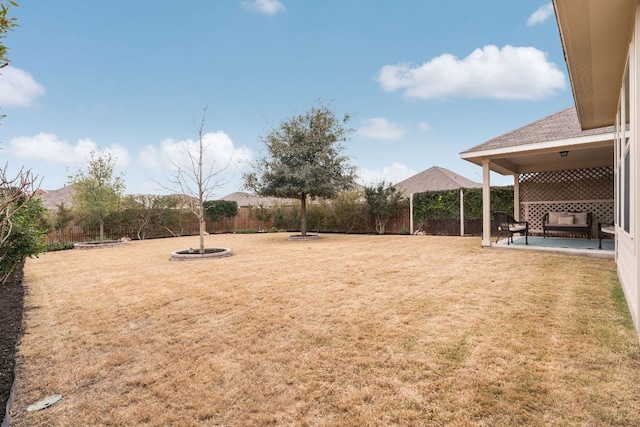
[[491, 236, 615, 259]]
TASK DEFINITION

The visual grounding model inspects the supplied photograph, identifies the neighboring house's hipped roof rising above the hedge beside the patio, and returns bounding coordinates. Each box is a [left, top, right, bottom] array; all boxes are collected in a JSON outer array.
[[395, 166, 482, 195]]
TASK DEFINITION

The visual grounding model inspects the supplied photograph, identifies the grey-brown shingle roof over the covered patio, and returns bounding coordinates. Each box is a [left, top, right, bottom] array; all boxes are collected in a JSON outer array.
[[462, 107, 613, 153]]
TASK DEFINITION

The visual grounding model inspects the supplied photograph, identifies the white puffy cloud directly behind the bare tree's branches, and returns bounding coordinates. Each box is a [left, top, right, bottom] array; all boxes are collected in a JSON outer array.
[[136, 131, 252, 175]]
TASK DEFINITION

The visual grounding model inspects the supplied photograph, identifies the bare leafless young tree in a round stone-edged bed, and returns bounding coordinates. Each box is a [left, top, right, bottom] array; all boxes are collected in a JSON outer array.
[[160, 107, 232, 254]]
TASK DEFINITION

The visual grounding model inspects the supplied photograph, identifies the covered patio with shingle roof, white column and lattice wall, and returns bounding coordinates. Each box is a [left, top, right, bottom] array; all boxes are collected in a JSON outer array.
[[460, 107, 615, 253]]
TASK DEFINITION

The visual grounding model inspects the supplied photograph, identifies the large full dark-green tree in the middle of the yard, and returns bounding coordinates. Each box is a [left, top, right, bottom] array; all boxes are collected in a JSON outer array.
[[244, 103, 355, 236]]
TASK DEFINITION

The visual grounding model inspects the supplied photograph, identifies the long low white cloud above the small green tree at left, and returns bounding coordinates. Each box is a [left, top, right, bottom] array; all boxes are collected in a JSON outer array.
[[8, 132, 130, 167]]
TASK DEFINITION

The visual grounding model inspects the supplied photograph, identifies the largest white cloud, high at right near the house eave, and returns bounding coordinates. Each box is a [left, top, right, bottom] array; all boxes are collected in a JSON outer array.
[[378, 45, 566, 100]]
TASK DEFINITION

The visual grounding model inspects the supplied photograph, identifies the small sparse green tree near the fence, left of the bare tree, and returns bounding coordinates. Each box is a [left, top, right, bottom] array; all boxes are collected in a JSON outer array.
[[68, 151, 124, 242]]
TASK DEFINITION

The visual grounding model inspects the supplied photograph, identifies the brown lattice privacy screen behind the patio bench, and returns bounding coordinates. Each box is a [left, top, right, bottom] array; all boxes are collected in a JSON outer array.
[[520, 167, 615, 234]]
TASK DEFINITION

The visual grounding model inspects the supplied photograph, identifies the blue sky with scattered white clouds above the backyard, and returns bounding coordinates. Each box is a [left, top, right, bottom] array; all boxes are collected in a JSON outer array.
[[0, 0, 573, 198]]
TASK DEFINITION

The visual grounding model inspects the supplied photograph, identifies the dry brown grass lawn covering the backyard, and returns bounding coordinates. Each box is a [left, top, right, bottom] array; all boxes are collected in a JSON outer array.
[[12, 234, 640, 426]]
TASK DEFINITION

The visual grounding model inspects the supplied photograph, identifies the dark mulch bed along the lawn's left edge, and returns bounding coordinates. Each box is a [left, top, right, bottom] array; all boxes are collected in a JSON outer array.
[[0, 268, 24, 422]]
